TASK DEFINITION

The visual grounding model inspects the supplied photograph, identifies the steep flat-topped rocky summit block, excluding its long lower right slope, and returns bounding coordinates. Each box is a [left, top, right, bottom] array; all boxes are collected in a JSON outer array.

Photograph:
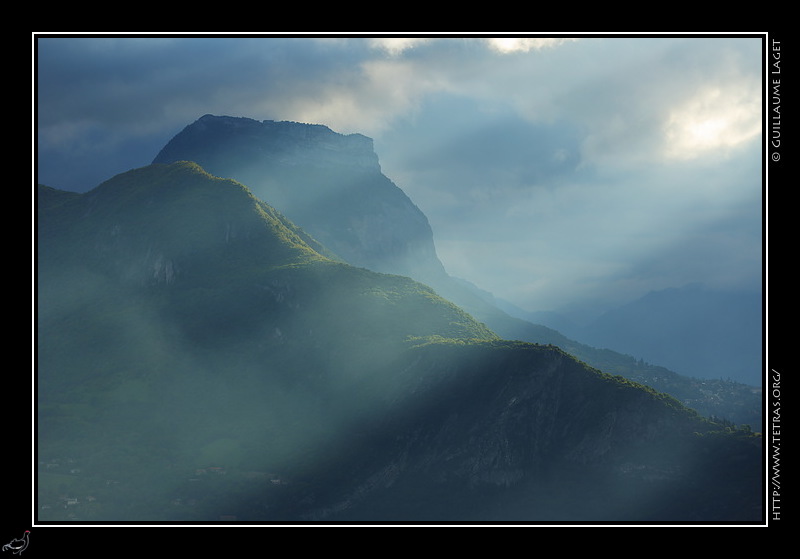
[[153, 115, 445, 281]]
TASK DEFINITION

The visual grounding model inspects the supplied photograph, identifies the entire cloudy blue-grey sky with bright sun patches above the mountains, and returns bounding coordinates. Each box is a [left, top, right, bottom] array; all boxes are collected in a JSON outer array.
[[33, 35, 763, 320]]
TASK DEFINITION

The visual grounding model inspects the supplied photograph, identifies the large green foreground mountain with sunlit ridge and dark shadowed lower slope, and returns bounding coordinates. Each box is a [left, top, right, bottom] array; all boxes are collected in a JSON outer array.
[[36, 162, 762, 524]]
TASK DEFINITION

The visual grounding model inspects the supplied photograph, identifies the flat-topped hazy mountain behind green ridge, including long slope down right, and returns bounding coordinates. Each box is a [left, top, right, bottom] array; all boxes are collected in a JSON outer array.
[[154, 115, 761, 429]]
